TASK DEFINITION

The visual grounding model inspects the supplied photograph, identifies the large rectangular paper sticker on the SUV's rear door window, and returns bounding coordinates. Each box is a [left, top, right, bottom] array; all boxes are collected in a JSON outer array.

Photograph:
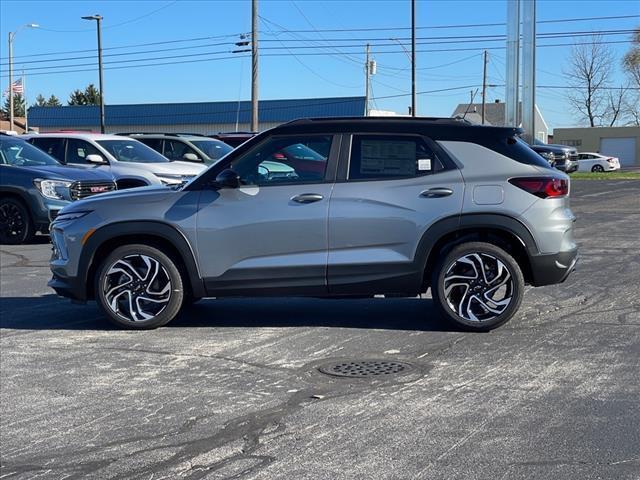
[[360, 140, 416, 176]]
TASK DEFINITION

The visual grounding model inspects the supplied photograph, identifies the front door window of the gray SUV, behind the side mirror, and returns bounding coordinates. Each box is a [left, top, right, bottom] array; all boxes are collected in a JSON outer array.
[[230, 135, 332, 185]]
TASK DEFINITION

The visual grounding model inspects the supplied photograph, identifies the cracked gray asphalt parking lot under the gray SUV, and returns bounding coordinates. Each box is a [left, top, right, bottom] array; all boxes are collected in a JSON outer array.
[[0, 181, 640, 480]]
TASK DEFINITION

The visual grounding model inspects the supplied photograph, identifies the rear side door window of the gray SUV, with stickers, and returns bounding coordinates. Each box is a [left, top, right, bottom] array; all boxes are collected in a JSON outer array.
[[349, 135, 442, 180]]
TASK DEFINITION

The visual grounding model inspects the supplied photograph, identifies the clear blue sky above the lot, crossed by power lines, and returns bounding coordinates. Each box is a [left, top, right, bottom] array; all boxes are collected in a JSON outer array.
[[0, 0, 640, 128]]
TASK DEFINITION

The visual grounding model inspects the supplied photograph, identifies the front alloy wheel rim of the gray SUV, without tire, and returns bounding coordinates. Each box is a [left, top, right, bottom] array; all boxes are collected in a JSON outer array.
[[102, 255, 172, 322]]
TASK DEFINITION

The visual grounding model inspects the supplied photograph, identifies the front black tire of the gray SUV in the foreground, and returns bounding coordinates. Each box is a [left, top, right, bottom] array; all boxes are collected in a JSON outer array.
[[95, 244, 185, 330]]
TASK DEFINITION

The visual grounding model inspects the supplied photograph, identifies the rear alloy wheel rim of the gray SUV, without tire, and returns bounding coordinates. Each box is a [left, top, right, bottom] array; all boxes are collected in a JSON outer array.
[[444, 253, 514, 322]]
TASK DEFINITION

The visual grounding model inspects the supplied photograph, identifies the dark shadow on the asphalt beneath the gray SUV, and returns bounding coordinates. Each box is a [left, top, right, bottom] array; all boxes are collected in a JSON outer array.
[[0, 295, 458, 331]]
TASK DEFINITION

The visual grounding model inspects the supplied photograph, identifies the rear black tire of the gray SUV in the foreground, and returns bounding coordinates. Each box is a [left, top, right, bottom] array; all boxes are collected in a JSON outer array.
[[431, 242, 524, 332]]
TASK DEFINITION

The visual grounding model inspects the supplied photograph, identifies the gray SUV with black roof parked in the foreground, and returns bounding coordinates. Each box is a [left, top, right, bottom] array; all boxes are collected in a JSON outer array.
[[49, 118, 577, 331]]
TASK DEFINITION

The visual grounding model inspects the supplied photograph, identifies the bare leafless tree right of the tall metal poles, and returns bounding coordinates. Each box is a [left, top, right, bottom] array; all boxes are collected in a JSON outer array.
[[565, 35, 619, 127]]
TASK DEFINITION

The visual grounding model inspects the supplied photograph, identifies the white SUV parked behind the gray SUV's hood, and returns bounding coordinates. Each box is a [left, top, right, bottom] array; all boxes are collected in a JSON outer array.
[[22, 132, 206, 190]]
